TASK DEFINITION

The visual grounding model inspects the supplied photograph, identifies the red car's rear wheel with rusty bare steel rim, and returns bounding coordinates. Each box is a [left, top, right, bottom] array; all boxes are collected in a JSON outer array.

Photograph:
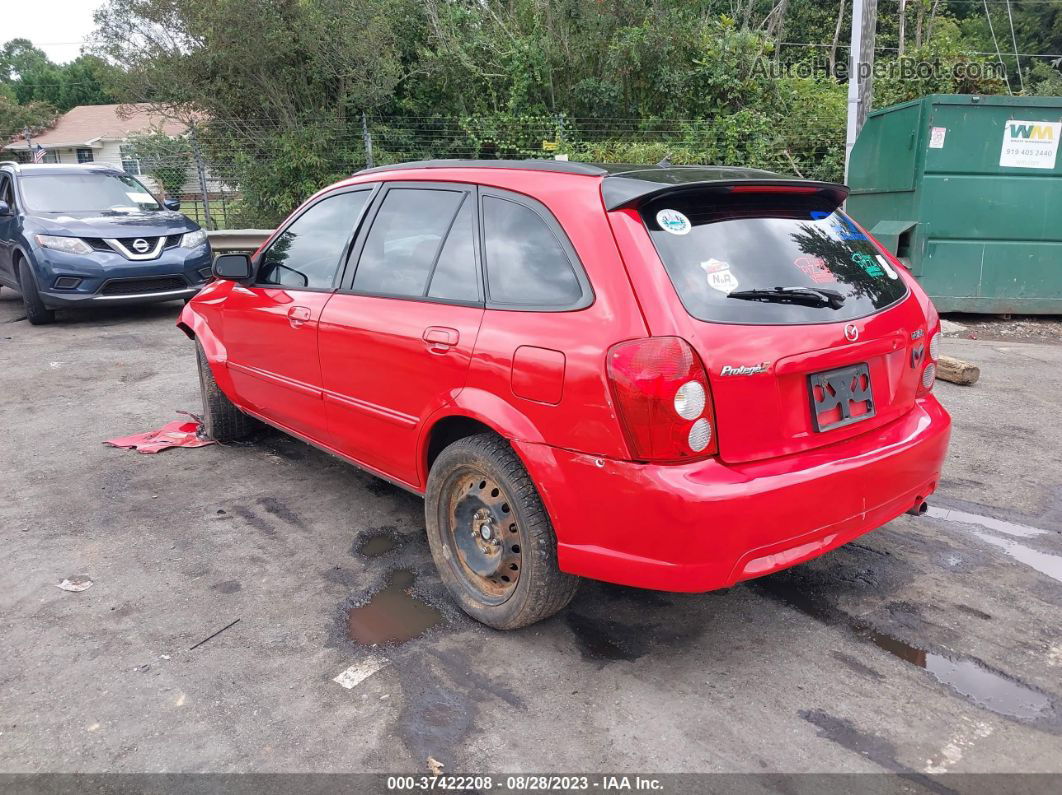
[[424, 433, 579, 629]]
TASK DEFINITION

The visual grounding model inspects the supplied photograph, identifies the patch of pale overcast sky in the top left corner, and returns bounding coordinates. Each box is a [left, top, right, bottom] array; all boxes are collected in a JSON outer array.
[[0, 0, 103, 64]]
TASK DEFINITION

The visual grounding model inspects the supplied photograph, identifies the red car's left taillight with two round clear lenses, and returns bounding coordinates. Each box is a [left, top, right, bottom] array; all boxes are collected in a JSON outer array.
[[607, 336, 718, 461]]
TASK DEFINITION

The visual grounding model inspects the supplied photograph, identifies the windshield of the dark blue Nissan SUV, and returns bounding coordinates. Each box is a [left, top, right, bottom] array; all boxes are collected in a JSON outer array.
[[21, 172, 161, 212]]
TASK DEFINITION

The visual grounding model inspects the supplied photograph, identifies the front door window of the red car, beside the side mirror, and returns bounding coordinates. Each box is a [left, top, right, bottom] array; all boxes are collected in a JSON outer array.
[[255, 190, 371, 289]]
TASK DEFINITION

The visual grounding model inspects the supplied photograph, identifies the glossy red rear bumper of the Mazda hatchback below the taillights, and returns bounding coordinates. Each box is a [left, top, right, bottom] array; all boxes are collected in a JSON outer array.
[[514, 396, 950, 591]]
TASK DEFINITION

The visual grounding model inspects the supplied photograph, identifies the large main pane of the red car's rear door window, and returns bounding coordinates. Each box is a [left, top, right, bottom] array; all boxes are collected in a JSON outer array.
[[354, 188, 463, 297]]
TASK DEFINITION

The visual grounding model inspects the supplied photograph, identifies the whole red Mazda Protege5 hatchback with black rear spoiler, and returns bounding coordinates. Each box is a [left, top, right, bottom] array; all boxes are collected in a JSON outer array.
[[178, 160, 950, 628]]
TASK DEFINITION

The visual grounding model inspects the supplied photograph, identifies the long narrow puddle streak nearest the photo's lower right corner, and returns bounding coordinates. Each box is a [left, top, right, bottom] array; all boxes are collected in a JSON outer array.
[[754, 573, 1059, 725]]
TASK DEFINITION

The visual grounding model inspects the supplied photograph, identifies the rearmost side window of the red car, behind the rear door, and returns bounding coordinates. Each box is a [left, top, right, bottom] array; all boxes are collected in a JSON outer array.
[[483, 196, 583, 309]]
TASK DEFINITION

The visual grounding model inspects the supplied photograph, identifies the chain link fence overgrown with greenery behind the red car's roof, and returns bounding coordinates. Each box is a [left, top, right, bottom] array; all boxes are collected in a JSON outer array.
[[99, 111, 844, 229]]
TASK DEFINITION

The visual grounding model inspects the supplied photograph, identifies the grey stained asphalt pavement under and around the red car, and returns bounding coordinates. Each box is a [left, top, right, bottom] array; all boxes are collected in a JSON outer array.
[[0, 289, 1062, 774]]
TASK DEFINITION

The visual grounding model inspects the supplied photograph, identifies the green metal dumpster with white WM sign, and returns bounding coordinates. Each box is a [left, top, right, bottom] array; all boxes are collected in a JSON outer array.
[[847, 94, 1062, 314]]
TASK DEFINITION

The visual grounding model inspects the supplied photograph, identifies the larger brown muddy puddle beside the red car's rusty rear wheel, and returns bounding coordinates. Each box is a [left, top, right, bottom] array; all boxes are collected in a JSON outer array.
[[346, 569, 443, 645]]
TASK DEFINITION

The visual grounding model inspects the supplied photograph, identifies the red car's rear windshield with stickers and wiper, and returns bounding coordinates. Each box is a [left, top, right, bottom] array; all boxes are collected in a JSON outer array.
[[641, 191, 907, 325]]
